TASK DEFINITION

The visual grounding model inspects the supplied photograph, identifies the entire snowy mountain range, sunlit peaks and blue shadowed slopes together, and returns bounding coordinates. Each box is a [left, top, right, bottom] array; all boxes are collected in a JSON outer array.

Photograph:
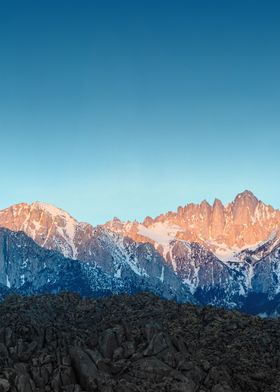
[[0, 191, 280, 315]]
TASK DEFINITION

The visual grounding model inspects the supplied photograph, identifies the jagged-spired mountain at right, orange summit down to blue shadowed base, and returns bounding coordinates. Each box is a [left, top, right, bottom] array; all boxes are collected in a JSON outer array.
[[103, 191, 280, 311]]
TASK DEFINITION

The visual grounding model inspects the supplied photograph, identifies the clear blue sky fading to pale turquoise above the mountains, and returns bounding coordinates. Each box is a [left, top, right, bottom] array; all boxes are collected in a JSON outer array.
[[0, 0, 280, 224]]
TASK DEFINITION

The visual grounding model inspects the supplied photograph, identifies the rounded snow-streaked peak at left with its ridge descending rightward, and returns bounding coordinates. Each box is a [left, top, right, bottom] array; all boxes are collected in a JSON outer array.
[[0, 202, 191, 300]]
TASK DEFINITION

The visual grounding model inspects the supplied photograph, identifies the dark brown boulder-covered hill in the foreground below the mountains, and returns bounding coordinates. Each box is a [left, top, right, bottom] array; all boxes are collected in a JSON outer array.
[[0, 294, 280, 392]]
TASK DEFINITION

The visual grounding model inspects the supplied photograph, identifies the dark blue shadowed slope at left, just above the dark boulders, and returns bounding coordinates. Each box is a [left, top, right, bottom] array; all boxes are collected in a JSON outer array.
[[0, 228, 192, 301]]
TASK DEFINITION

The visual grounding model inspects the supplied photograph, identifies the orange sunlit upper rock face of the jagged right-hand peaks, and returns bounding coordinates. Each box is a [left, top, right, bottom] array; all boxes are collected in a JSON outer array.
[[106, 191, 280, 260]]
